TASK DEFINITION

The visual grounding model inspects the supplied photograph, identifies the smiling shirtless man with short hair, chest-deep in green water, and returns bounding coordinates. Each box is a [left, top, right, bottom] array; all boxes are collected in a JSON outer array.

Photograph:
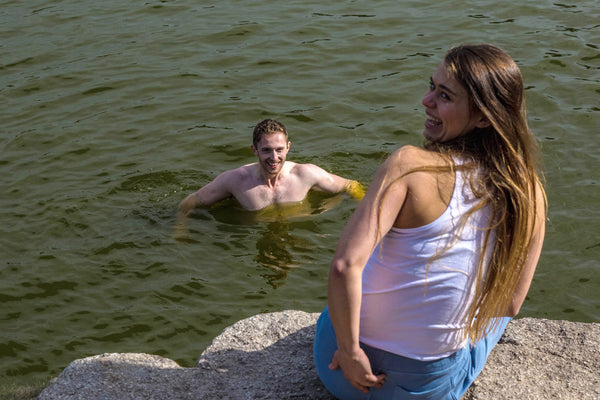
[[178, 119, 364, 218]]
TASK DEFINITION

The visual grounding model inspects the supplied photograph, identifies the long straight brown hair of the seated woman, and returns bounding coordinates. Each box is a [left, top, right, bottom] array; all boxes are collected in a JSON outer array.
[[425, 44, 546, 341]]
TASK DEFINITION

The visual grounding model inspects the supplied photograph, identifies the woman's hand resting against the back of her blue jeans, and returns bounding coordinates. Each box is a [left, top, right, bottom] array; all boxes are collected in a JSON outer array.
[[329, 348, 385, 393]]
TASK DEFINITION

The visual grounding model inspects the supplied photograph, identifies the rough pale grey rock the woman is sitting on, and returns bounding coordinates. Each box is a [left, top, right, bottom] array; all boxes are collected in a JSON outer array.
[[38, 311, 600, 400]]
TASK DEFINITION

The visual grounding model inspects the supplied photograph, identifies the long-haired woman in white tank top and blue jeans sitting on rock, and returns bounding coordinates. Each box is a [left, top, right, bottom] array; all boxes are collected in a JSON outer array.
[[314, 45, 546, 400]]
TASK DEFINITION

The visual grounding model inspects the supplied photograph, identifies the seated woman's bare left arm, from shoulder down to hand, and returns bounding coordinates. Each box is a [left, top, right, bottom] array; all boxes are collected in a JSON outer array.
[[328, 149, 408, 393]]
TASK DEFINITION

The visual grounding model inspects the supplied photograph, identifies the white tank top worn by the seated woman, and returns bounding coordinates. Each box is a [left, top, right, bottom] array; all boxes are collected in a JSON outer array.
[[360, 167, 495, 361]]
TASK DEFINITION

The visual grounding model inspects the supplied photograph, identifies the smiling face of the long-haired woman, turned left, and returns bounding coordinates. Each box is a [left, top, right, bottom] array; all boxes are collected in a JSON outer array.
[[422, 63, 489, 142]]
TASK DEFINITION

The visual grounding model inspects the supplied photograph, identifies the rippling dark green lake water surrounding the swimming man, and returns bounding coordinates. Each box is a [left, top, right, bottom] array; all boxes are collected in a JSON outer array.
[[0, 0, 600, 388]]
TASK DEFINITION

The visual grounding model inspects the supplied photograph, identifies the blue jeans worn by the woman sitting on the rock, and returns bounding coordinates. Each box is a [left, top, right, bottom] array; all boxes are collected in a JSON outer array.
[[313, 307, 510, 400]]
